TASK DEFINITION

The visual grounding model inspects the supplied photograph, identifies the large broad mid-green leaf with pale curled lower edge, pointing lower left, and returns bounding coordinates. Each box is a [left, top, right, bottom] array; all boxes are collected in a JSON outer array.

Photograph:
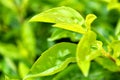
[[24, 42, 76, 80]]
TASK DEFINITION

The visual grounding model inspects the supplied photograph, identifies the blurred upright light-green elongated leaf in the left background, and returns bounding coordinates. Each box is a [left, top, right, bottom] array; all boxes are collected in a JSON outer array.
[[21, 22, 36, 58]]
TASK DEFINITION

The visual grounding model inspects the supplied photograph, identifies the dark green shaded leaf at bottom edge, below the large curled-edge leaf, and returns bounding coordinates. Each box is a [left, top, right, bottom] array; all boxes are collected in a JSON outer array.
[[52, 64, 81, 80]]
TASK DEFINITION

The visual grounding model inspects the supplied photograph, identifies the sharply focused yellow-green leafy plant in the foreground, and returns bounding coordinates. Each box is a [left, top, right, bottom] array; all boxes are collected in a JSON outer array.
[[24, 7, 120, 80]]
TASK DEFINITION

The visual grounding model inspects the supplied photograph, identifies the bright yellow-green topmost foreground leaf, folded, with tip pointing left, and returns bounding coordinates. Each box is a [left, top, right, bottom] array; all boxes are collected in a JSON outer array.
[[30, 7, 85, 34]]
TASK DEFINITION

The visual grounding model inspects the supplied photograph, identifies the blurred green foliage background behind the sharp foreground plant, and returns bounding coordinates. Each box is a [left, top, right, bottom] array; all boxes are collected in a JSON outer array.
[[0, 0, 120, 80]]
